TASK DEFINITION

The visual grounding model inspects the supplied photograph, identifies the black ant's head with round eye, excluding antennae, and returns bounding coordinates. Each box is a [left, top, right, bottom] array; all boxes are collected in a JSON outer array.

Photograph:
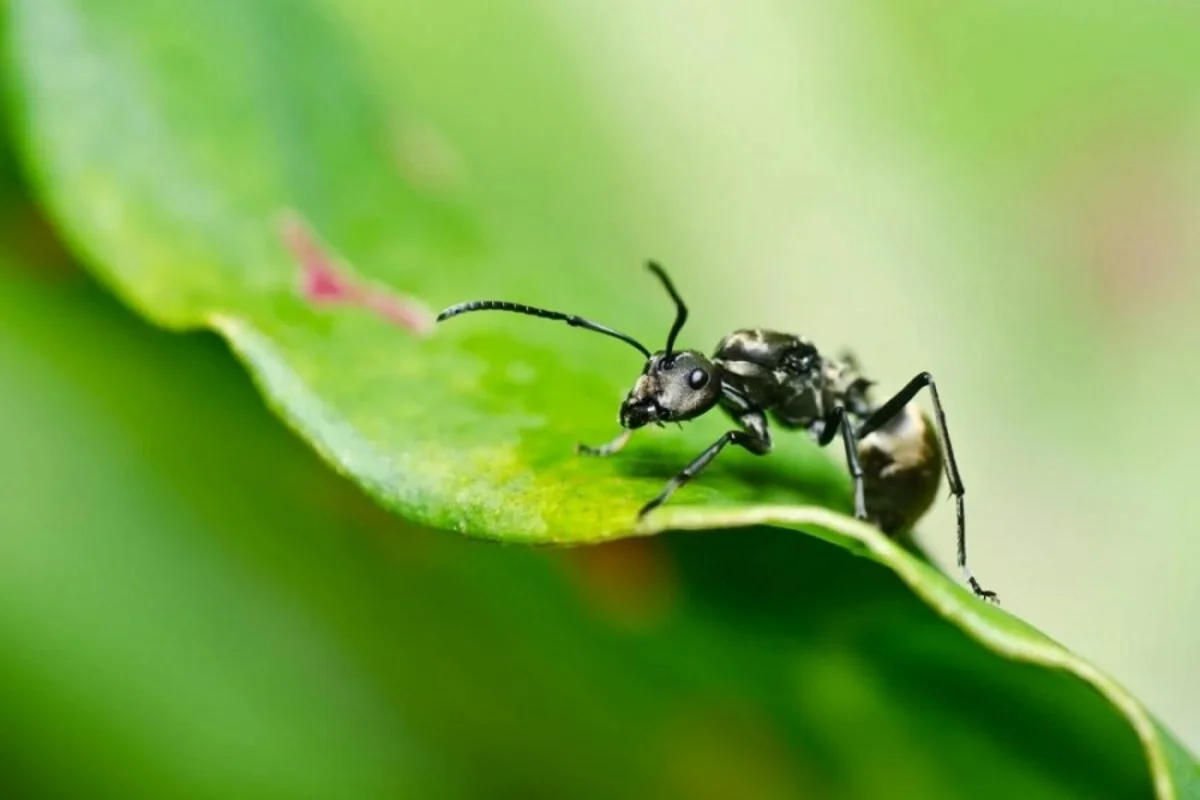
[[620, 350, 721, 429]]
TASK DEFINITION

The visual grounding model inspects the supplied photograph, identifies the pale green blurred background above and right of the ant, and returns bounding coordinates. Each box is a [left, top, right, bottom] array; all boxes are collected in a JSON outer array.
[[544, 1, 1200, 746]]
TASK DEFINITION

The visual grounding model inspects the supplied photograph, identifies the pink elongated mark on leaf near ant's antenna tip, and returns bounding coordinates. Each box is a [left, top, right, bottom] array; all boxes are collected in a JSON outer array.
[[280, 212, 433, 333]]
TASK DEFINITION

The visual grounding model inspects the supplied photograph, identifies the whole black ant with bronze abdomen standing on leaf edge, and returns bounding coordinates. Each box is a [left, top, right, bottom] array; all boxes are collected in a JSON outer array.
[[438, 261, 996, 601]]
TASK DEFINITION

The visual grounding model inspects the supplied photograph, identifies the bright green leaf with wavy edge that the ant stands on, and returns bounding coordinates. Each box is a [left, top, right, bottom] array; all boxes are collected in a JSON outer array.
[[10, 0, 1195, 798]]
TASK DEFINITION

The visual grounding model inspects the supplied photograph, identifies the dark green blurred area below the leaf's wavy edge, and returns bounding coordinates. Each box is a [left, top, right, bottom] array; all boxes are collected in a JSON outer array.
[[0, 259, 1189, 800]]
